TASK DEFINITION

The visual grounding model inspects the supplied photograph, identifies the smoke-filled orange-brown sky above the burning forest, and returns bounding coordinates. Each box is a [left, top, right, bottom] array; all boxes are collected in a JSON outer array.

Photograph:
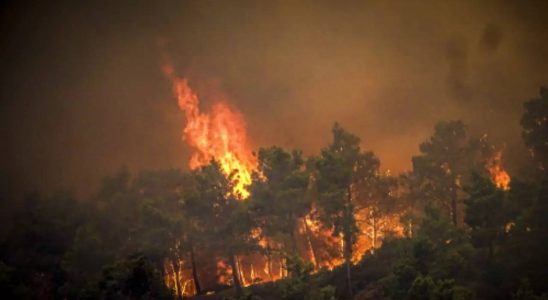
[[0, 0, 548, 195]]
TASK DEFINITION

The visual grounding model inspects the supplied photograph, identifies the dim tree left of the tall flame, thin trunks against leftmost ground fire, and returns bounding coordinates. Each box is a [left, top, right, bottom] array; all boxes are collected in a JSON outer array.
[[133, 170, 195, 298]]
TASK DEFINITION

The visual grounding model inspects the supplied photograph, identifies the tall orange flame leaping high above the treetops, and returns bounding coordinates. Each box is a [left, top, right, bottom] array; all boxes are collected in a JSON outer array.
[[164, 66, 256, 199]]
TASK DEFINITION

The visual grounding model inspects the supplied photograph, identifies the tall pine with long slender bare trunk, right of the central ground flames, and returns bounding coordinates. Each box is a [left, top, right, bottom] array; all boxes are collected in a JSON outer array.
[[316, 123, 379, 297]]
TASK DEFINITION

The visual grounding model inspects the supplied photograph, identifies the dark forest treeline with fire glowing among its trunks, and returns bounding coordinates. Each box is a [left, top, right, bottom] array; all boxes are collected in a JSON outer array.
[[0, 88, 548, 300]]
